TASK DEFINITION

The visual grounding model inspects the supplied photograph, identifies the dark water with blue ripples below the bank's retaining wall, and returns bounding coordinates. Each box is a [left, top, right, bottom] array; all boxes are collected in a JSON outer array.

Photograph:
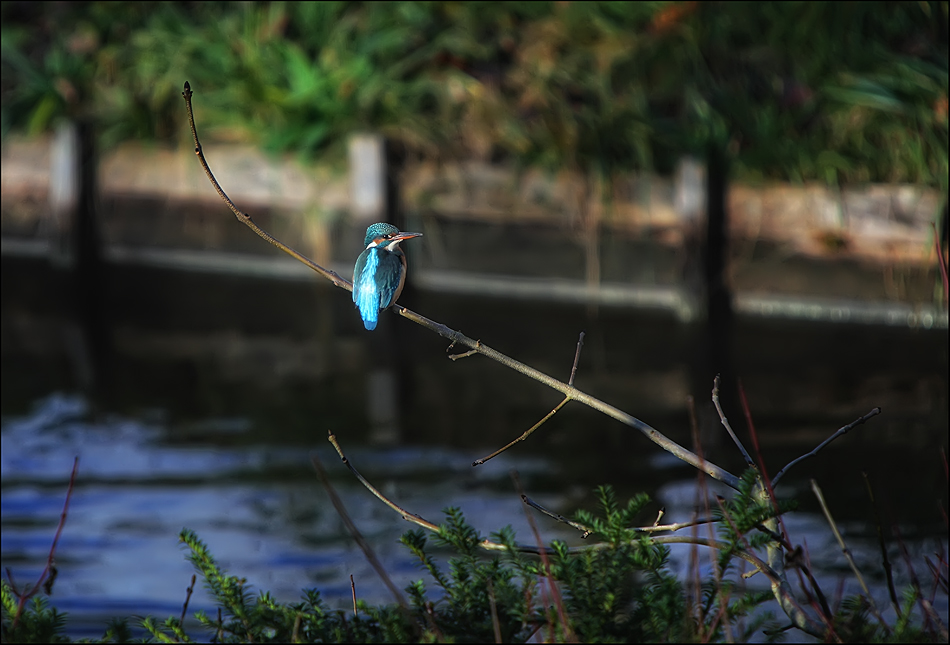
[[0, 259, 948, 635]]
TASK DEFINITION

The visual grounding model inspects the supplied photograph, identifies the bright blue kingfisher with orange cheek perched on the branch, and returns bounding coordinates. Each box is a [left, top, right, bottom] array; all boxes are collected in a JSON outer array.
[[353, 222, 422, 330]]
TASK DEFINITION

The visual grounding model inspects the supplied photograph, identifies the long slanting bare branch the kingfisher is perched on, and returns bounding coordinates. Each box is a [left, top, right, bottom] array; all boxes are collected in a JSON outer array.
[[182, 83, 739, 488]]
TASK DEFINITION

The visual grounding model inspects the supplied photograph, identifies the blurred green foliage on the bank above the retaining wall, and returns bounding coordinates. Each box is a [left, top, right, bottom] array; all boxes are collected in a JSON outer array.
[[2, 2, 948, 191]]
